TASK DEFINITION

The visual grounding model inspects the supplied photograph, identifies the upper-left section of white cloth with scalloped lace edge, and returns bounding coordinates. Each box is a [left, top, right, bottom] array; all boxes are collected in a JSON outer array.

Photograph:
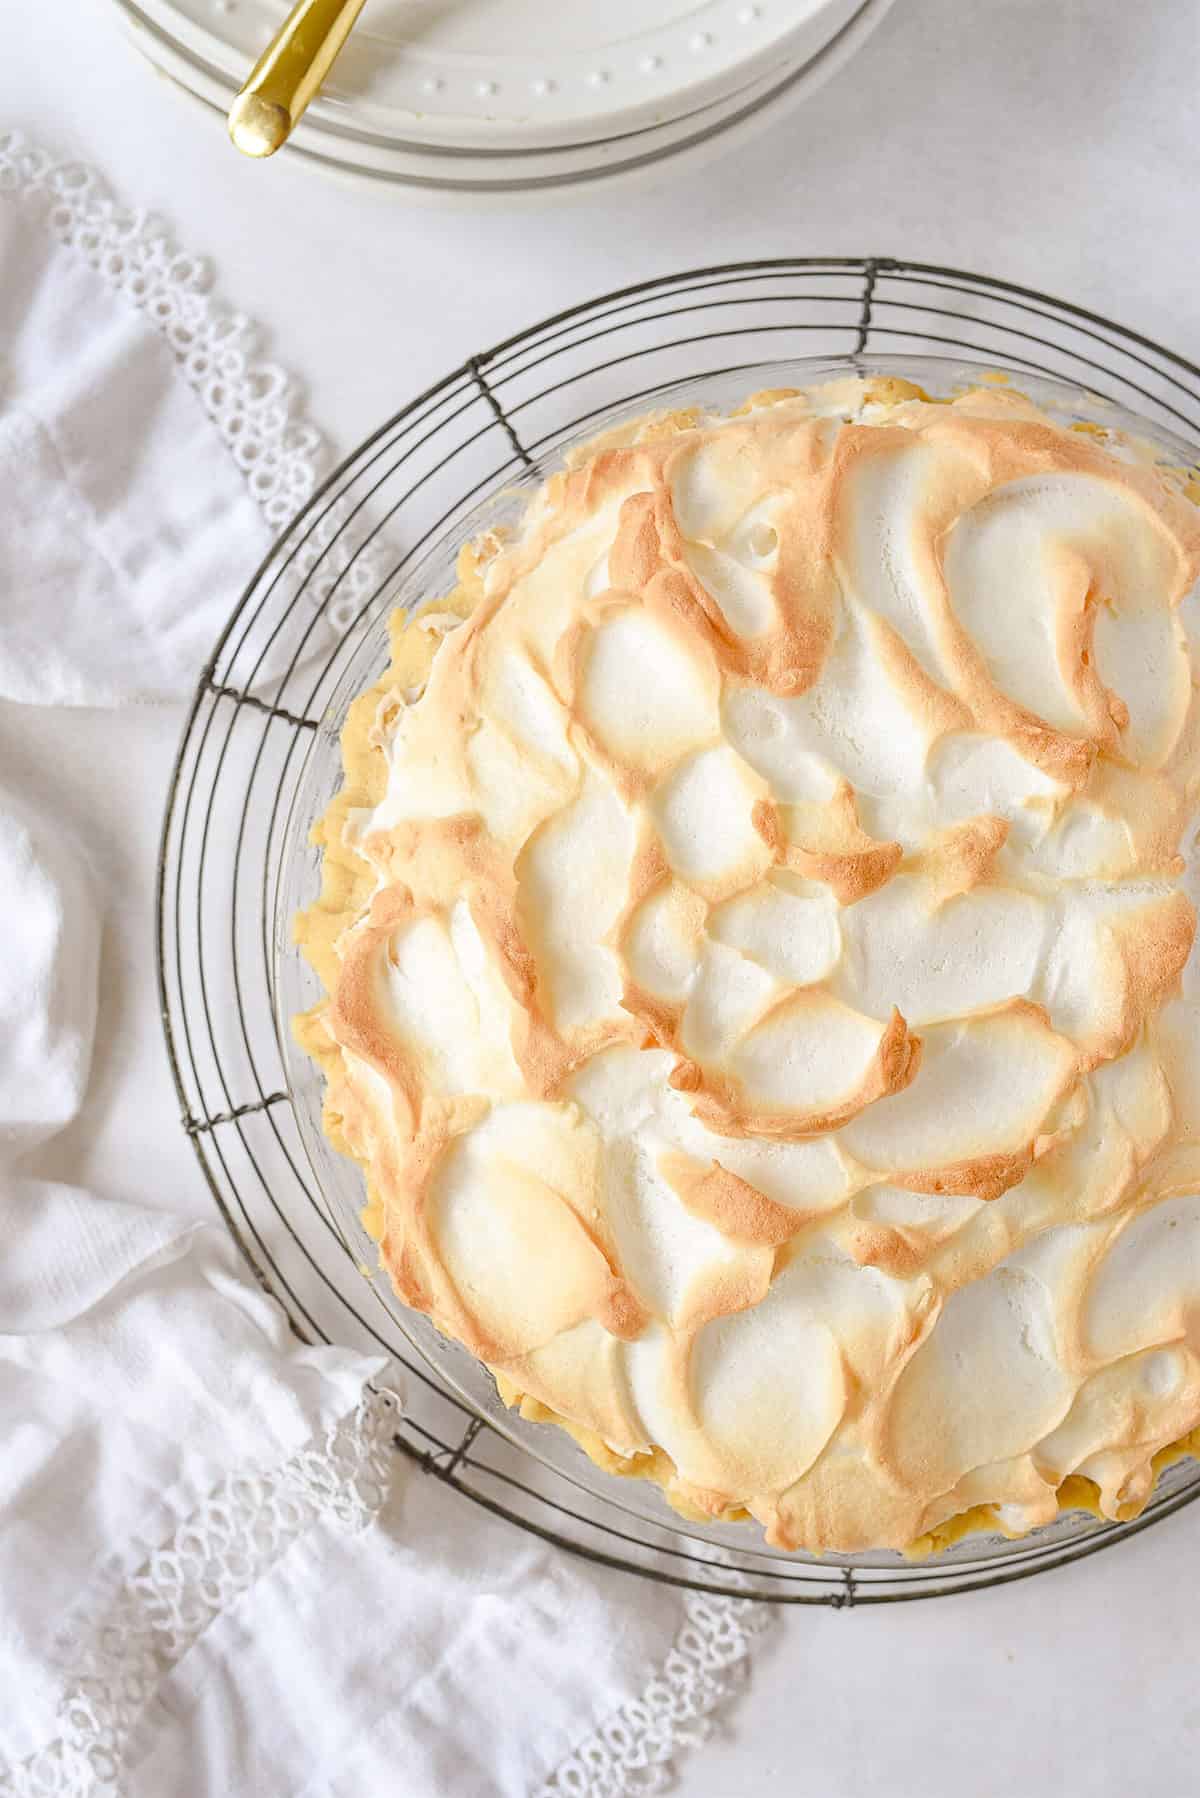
[[0, 133, 320, 705]]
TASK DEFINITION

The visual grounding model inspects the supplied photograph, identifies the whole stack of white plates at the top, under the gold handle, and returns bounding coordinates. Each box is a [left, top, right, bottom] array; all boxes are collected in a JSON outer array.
[[117, 0, 891, 194]]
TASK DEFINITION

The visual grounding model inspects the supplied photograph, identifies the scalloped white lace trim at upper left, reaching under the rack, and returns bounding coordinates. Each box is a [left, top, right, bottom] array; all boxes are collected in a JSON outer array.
[[0, 131, 378, 631]]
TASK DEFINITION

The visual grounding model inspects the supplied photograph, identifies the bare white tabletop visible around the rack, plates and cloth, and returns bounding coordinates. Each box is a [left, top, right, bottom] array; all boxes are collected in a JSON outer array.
[[0, 0, 1200, 1798]]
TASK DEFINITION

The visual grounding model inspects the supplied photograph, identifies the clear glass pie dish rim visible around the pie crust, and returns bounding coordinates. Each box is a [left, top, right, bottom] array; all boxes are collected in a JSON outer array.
[[272, 356, 1200, 1584]]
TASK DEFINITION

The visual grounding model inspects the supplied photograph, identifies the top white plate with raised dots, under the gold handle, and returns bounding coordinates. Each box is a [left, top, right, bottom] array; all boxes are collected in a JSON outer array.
[[115, 0, 856, 149]]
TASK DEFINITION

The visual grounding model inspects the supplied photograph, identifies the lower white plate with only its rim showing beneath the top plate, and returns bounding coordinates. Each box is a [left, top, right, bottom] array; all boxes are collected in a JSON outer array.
[[117, 0, 892, 200]]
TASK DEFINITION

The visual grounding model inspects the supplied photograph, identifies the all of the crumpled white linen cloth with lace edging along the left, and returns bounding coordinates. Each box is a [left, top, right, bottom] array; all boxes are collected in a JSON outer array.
[[0, 137, 761, 1798]]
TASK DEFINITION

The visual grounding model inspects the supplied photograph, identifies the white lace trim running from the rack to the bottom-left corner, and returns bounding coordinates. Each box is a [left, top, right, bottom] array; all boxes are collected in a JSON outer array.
[[0, 1390, 396, 1798]]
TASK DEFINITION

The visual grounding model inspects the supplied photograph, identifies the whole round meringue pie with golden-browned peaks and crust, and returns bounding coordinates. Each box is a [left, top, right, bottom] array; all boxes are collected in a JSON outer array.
[[302, 381, 1200, 1550]]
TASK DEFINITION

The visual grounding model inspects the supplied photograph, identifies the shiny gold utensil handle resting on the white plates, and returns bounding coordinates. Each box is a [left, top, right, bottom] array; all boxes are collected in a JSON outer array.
[[228, 0, 365, 156]]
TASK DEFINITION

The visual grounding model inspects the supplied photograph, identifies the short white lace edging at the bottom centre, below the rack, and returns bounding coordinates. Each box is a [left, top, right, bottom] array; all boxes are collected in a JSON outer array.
[[538, 1596, 768, 1798]]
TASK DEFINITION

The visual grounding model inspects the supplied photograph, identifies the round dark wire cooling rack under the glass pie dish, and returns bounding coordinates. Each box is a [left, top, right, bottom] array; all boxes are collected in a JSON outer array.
[[158, 257, 1200, 1607]]
